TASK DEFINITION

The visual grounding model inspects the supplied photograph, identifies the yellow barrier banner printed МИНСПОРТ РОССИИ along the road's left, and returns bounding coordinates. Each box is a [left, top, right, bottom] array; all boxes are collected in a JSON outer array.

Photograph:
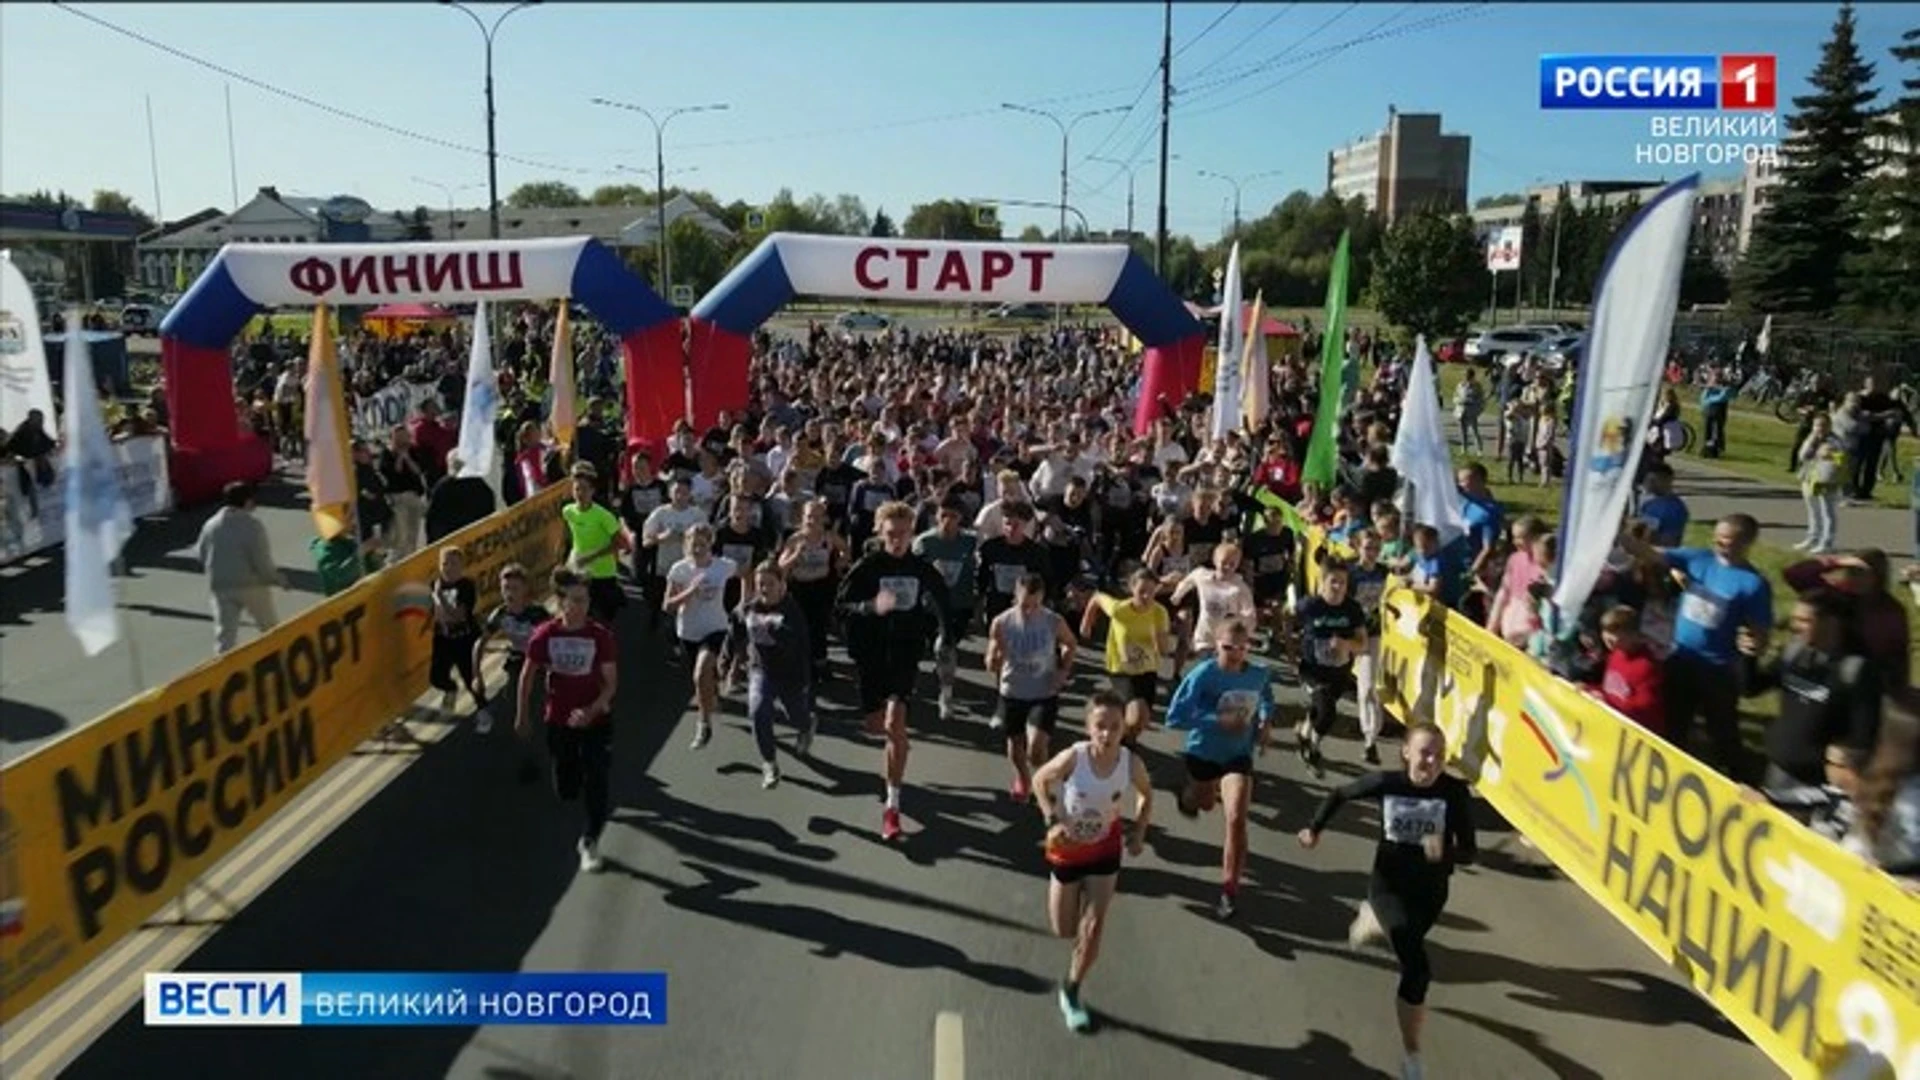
[[0, 488, 566, 1022]]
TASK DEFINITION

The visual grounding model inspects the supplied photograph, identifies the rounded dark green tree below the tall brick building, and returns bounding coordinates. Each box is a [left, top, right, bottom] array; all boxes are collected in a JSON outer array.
[[1371, 211, 1486, 340]]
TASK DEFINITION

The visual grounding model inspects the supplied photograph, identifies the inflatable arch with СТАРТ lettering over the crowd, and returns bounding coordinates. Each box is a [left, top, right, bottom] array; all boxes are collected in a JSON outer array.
[[691, 233, 1206, 432]]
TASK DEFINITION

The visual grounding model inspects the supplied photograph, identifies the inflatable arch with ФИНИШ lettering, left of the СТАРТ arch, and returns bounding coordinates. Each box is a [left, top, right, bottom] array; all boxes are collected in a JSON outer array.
[[159, 236, 684, 503]]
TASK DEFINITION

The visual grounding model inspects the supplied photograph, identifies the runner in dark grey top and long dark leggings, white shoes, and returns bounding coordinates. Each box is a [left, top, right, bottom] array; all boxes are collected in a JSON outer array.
[[728, 561, 814, 788]]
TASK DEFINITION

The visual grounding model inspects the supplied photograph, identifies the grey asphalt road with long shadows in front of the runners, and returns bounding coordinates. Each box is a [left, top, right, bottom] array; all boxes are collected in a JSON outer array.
[[52, 599, 1772, 1080]]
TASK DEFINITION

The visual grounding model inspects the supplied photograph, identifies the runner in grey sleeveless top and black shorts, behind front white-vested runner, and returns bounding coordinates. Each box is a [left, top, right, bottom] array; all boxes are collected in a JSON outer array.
[[987, 575, 1079, 803]]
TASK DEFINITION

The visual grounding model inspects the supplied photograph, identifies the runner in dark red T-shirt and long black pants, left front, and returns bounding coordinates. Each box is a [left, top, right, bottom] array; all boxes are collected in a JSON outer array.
[[513, 569, 618, 874]]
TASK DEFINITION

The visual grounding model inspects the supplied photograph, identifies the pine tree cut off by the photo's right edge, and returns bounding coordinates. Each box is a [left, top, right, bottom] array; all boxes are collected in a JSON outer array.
[[1847, 29, 1920, 323]]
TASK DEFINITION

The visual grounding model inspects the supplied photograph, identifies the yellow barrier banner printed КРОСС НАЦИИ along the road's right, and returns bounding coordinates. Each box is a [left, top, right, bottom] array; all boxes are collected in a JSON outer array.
[[1380, 588, 1920, 1080]]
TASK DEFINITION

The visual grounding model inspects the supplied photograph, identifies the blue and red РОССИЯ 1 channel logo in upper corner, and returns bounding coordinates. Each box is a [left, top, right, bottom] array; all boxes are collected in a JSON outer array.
[[1540, 54, 1774, 111]]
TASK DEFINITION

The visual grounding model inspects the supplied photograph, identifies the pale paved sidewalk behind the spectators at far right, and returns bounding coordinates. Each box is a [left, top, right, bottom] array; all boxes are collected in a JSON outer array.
[[1667, 454, 1914, 571]]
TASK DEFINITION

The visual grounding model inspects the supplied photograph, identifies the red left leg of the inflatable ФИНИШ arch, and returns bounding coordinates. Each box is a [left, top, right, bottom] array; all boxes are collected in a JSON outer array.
[[159, 338, 273, 505]]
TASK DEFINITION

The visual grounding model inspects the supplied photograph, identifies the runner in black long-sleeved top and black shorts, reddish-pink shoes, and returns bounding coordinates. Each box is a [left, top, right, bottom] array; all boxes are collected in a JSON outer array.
[[835, 502, 948, 840]]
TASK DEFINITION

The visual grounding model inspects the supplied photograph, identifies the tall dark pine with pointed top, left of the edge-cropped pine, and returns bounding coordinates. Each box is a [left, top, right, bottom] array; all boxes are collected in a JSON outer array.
[[1740, 4, 1878, 315]]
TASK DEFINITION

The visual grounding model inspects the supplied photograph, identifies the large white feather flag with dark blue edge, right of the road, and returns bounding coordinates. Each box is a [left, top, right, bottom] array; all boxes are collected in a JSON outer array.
[[1553, 173, 1699, 613]]
